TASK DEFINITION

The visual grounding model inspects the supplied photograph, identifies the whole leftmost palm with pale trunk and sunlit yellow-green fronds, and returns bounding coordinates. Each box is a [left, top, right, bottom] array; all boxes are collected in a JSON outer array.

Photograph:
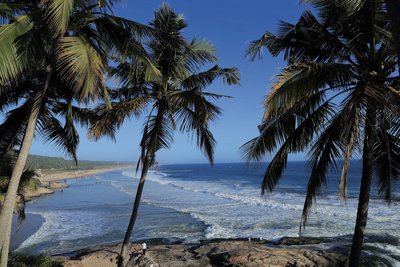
[[0, 0, 151, 266]]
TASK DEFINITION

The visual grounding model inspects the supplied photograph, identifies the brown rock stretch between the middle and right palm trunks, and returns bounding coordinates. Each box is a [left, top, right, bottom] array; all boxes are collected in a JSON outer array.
[[128, 241, 347, 267]]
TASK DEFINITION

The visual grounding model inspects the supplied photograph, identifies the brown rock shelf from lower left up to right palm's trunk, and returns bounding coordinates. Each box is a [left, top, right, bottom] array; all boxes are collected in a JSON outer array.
[[56, 240, 347, 267]]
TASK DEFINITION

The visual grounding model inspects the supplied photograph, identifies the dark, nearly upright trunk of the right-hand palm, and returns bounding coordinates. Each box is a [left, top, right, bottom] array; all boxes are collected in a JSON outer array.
[[349, 111, 375, 267]]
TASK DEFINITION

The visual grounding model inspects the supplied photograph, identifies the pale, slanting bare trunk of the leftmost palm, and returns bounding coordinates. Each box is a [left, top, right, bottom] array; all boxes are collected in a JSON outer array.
[[0, 70, 52, 267]]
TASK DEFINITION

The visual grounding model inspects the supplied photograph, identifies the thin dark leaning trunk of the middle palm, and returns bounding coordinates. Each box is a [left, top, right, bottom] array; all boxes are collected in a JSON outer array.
[[118, 109, 163, 267]]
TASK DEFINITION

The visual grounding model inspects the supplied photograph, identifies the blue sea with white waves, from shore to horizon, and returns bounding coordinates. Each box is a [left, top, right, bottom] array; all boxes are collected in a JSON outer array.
[[10, 162, 400, 260]]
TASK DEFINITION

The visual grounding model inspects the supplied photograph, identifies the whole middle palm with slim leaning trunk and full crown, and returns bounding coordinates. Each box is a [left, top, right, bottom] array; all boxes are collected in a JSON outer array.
[[90, 5, 239, 266]]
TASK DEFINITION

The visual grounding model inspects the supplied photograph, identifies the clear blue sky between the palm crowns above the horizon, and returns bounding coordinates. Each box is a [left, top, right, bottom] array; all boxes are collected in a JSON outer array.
[[31, 0, 309, 164]]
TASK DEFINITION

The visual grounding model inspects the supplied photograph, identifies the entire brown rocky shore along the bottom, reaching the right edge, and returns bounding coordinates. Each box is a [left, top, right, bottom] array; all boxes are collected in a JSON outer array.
[[56, 235, 399, 267]]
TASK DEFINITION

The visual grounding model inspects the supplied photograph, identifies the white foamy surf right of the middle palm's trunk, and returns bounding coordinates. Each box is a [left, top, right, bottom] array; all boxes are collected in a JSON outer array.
[[117, 168, 400, 239]]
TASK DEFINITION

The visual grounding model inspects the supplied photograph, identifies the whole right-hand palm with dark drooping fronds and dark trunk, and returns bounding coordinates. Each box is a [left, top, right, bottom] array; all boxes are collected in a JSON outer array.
[[242, 0, 400, 266]]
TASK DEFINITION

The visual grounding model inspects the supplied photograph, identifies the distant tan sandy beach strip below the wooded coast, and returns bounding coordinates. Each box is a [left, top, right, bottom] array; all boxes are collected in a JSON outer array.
[[41, 165, 133, 182]]
